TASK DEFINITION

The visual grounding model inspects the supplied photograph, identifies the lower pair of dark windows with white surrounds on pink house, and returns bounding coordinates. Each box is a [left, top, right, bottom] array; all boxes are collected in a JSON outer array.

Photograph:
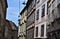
[[34, 24, 47, 38]]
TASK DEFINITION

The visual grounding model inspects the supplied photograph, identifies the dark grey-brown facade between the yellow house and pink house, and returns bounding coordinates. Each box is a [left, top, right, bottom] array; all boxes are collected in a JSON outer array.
[[26, 0, 36, 39]]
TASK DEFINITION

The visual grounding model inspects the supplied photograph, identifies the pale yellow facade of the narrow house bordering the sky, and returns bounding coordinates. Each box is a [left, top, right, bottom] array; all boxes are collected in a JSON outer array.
[[19, 9, 27, 39]]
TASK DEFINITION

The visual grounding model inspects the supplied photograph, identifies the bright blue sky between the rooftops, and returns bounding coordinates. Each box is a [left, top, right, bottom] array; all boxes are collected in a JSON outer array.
[[6, 0, 27, 26]]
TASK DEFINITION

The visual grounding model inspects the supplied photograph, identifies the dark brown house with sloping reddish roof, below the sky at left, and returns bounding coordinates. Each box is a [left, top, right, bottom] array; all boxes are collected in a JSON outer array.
[[4, 20, 18, 39]]
